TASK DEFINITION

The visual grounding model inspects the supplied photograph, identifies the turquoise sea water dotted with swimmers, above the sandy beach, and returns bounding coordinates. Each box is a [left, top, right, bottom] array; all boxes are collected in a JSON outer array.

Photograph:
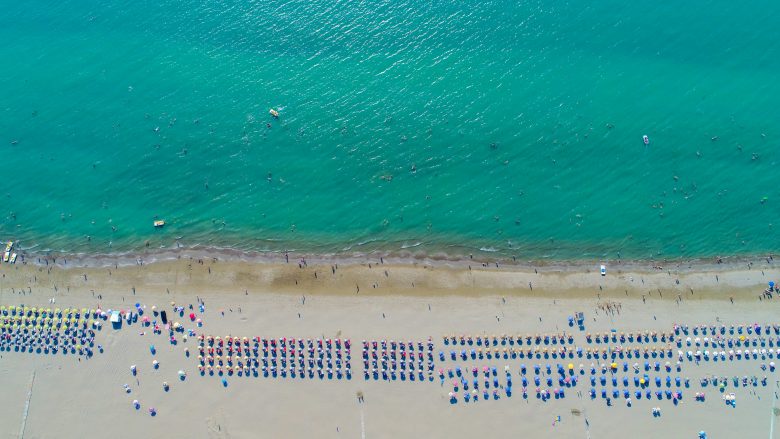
[[0, 0, 780, 258]]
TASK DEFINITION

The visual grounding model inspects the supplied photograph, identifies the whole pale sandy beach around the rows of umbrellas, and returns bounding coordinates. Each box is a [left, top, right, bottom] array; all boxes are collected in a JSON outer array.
[[0, 251, 780, 438]]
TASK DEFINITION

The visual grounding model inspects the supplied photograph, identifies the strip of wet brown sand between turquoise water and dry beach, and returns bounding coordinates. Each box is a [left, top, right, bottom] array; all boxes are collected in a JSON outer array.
[[0, 244, 780, 301]]
